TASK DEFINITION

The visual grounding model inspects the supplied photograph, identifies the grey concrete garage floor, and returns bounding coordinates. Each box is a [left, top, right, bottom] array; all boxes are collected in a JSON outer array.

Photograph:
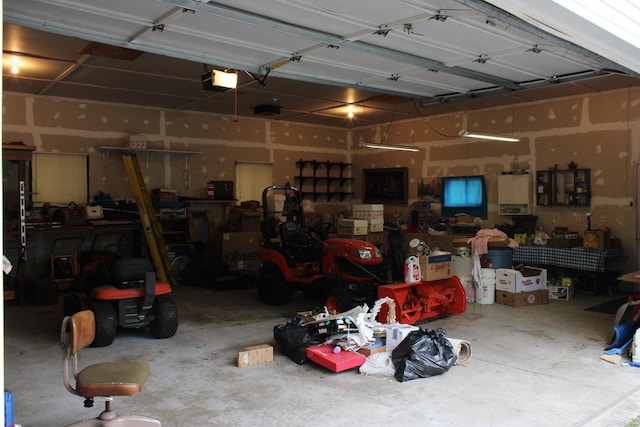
[[5, 287, 640, 427]]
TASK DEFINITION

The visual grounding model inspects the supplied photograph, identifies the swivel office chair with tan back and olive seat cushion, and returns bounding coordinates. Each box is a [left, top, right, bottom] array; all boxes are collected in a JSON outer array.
[[60, 310, 161, 427]]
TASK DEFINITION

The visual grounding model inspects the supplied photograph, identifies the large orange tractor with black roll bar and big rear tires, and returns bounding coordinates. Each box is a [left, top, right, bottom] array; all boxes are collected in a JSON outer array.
[[257, 186, 386, 313]]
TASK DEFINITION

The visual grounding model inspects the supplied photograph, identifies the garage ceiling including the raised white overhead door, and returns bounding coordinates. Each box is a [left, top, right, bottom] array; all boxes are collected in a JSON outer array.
[[3, 0, 640, 127]]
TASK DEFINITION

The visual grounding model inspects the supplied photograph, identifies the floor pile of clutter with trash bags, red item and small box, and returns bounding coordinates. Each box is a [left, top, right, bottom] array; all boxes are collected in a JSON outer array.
[[238, 297, 471, 382]]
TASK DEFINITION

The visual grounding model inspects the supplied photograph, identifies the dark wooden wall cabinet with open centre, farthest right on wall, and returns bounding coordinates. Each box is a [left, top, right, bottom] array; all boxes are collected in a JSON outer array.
[[536, 169, 591, 206]]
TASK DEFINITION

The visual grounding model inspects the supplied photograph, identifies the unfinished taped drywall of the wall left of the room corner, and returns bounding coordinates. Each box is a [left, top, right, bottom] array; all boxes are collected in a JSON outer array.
[[3, 93, 348, 224]]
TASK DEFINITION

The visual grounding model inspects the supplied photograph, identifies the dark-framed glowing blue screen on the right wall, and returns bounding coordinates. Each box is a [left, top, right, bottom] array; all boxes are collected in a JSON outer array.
[[441, 175, 487, 219]]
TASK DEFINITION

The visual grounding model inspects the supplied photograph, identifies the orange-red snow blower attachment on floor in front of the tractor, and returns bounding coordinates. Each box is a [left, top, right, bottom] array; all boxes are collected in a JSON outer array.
[[378, 276, 467, 324]]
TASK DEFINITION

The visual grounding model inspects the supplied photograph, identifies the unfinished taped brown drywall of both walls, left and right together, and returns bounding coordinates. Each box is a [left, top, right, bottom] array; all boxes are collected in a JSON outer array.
[[3, 88, 640, 270]]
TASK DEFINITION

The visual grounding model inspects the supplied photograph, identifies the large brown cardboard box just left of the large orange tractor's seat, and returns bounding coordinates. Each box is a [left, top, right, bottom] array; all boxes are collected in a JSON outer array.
[[222, 232, 262, 271]]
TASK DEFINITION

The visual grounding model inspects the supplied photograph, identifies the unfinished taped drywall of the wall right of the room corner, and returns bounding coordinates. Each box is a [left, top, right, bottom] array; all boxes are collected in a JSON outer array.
[[352, 88, 640, 270]]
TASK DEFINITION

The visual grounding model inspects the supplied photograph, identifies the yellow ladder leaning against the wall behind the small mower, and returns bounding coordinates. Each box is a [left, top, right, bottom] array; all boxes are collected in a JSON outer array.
[[122, 153, 177, 285]]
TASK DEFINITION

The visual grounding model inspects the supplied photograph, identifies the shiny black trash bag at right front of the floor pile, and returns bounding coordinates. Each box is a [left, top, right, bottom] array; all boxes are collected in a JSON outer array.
[[391, 328, 458, 382]]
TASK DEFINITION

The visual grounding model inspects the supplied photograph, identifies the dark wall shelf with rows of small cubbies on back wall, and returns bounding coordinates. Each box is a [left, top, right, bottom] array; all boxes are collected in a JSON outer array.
[[295, 160, 353, 201]]
